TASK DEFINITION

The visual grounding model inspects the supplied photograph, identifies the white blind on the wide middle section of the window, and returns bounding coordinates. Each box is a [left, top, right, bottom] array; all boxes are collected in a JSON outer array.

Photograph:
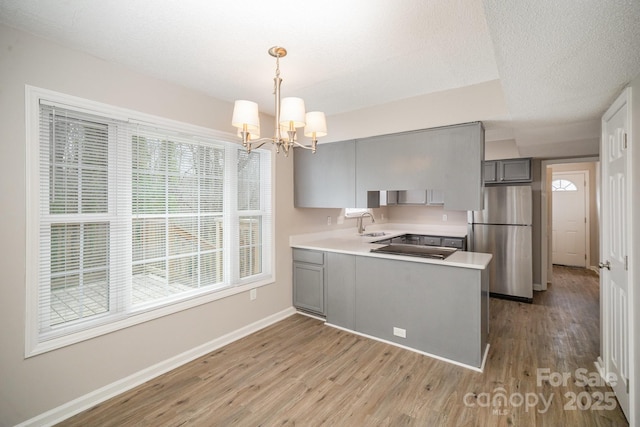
[[132, 128, 225, 306]]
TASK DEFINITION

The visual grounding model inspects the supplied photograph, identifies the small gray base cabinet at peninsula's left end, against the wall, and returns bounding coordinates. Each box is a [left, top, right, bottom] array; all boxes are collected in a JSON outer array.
[[293, 248, 326, 316]]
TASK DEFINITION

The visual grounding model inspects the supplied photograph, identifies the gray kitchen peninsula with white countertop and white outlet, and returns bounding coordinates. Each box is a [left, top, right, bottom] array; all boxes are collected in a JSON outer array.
[[290, 224, 491, 371]]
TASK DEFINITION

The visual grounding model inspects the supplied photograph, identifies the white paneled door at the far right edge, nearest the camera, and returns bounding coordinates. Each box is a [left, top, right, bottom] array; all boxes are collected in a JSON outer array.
[[600, 89, 631, 418]]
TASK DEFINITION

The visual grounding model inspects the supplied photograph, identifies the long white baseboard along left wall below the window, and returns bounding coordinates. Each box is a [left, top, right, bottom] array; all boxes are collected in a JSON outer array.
[[16, 307, 296, 427]]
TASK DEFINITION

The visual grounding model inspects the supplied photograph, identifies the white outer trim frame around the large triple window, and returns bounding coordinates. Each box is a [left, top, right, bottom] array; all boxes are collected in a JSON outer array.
[[25, 85, 276, 358]]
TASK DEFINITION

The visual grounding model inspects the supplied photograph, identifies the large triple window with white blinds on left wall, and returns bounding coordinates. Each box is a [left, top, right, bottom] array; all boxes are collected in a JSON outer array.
[[28, 88, 272, 354]]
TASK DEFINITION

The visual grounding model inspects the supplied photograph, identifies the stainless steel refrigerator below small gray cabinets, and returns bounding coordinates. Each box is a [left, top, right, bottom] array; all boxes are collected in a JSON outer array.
[[468, 185, 533, 302]]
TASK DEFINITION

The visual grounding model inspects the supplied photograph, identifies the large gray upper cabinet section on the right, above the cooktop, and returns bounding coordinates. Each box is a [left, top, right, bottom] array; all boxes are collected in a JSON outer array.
[[356, 122, 484, 210]]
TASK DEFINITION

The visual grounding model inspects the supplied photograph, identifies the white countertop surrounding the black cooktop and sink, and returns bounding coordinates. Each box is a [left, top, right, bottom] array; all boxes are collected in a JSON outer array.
[[289, 224, 492, 270]]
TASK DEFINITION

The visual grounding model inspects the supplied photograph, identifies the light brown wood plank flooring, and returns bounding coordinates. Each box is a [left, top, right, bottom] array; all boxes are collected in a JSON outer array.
[[59, 267, 628, 426]]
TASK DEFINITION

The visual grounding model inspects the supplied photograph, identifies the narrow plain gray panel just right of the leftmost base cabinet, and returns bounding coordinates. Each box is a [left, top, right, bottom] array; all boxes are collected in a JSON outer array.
[[327, 252, 356, 330]]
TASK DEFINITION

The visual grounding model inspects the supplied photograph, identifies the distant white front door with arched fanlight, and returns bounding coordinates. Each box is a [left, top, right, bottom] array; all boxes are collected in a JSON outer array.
[[551, 172, 587, 267]]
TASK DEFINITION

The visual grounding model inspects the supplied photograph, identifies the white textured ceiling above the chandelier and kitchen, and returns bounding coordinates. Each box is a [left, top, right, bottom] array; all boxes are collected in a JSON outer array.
[[0, 0, 640, 157]]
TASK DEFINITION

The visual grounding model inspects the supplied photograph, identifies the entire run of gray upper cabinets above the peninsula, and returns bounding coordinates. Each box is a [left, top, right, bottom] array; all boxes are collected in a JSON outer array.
[[293, 122, 484, 210]]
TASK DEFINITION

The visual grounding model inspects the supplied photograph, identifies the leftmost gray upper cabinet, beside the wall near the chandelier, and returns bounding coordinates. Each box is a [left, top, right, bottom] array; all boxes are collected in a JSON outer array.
[[293, 141, 356, 208]]
